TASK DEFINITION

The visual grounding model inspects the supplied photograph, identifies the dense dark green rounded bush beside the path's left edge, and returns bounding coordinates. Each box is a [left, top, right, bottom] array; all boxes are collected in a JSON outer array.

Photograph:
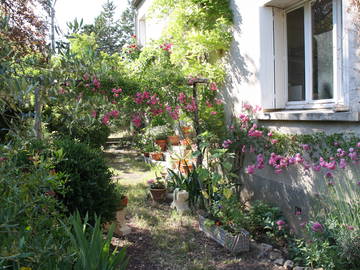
[[55, 139, 120, 225]]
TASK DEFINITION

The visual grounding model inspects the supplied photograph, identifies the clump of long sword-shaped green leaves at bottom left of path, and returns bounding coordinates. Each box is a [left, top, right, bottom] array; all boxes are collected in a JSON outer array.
[[66, 212, 128, 270]]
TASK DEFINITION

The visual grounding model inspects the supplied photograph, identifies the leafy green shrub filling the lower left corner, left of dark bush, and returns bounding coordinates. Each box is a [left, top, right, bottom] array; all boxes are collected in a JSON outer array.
[[0, 143, 69, 269]]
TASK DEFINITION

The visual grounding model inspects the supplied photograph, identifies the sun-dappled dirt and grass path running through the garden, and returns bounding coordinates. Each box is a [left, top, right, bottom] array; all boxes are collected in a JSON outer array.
[[106, 139, 277, 270]]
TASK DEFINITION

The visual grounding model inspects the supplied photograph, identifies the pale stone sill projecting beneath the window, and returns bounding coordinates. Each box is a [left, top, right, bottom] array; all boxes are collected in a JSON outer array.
[[257, 110, 360, 122]]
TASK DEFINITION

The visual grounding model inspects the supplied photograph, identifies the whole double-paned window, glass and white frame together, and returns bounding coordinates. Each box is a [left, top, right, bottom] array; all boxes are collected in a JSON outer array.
[[285, 0, 341, 107]]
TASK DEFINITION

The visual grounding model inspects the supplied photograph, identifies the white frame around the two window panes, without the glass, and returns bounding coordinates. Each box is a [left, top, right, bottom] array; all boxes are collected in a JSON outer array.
[[284, 0, 344, 109]]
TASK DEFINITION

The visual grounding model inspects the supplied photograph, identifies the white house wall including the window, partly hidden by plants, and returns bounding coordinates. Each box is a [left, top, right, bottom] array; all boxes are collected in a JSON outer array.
[[133, 0, 360, 228]]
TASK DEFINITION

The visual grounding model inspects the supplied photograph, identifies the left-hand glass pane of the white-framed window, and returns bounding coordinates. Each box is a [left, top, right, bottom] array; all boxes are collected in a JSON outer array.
[[286, 7, 305, 101]]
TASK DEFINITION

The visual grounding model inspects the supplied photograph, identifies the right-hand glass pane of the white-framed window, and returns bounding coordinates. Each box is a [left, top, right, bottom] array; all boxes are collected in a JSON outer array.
[[311, 0, 334, 99]]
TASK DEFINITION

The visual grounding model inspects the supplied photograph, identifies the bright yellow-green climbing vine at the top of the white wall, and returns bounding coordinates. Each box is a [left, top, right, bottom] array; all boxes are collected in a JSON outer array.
[[151, 0, 232, 82]]
